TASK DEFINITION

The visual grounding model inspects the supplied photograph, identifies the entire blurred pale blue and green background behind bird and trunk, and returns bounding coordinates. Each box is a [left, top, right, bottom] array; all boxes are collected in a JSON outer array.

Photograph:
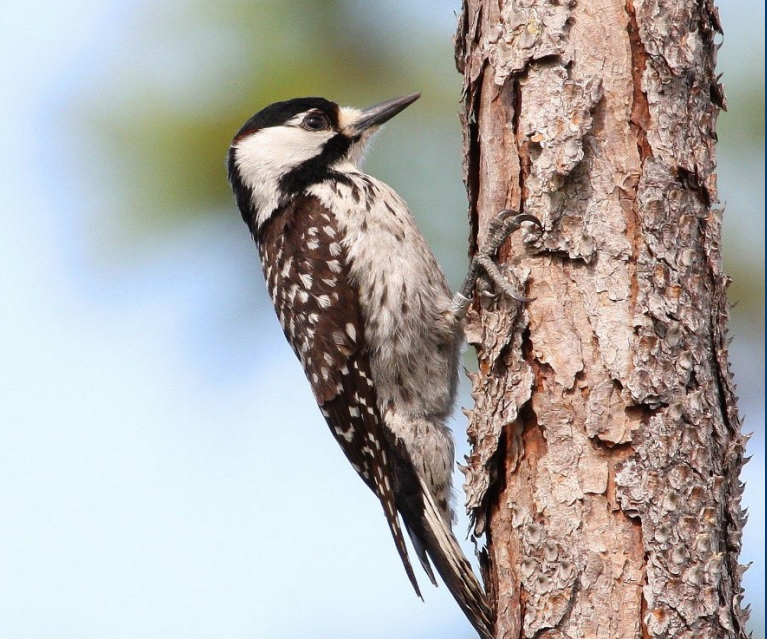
[[0, 0, 765, 639]]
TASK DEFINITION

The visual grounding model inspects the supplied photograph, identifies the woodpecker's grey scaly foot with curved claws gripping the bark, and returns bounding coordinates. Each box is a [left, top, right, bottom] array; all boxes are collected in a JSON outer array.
[[451, 209, 543, 319]]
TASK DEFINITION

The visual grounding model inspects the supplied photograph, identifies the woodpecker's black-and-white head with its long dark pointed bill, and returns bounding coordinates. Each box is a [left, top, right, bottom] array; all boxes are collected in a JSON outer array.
[[227, 93, 421, 228]]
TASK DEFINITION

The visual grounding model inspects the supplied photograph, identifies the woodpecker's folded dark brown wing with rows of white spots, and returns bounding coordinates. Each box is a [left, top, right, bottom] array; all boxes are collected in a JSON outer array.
[[257, 196, 421, 597]]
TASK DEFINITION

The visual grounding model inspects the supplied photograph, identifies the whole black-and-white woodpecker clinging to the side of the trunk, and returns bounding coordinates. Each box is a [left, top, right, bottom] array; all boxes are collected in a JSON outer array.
[[227, 93, 540, 639]]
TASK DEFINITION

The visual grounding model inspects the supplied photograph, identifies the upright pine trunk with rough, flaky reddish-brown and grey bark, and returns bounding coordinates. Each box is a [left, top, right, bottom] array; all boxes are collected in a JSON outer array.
[[456, 0, 747, 639]]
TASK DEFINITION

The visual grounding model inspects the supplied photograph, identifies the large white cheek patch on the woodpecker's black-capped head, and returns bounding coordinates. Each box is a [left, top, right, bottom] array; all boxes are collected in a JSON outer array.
[[234, 126, 334, 222]]
